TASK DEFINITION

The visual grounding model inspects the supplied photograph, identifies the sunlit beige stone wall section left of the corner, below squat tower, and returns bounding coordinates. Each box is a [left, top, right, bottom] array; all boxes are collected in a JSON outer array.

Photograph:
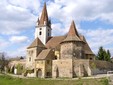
[[52, 59, 73, 78]]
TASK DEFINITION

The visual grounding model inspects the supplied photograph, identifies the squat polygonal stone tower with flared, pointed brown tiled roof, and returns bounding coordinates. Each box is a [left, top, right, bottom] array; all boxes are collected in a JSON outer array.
[[61, 21, 84, 59]]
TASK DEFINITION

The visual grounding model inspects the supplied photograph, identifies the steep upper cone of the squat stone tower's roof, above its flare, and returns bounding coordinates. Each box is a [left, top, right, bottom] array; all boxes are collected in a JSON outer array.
[[67, 21, 79, 37]]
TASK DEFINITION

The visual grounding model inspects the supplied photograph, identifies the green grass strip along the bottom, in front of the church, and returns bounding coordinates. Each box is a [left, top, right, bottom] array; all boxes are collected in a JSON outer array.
[[0, 75, 108, 85]]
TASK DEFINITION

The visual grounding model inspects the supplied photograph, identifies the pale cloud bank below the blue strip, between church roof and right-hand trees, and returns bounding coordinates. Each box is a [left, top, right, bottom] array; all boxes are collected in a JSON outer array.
[[82, 28, 113, 55]]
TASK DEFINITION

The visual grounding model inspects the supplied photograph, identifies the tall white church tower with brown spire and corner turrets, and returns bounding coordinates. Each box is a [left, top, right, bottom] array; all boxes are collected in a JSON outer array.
[[35, 3, 52, 45]]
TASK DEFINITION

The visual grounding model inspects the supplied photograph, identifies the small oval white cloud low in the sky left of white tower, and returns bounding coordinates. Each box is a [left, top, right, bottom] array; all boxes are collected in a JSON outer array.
[[10, 36, 29, 43]]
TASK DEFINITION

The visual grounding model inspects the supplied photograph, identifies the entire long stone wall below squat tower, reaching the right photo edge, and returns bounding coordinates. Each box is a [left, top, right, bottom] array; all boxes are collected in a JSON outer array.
[[52, 59, 113, 78]]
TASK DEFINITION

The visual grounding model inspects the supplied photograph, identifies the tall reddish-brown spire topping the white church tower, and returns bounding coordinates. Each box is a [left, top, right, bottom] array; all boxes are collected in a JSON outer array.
[[39, 2, 48, 25]]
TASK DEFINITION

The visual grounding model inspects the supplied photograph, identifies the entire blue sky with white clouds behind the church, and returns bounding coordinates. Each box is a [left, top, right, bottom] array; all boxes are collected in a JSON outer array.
[[0, 0, 113, 57]]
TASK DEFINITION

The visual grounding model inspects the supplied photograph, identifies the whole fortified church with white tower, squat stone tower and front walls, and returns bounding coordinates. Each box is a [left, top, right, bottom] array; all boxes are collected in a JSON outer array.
[[25, 3, 113, 78]]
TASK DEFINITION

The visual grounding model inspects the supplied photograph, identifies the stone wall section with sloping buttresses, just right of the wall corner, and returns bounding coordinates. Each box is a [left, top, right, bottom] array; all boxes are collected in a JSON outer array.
[[73, 59, 91, 77]]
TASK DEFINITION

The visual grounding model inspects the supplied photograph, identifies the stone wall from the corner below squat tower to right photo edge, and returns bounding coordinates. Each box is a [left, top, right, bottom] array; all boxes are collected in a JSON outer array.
[[73, 59, 113, 77]]
